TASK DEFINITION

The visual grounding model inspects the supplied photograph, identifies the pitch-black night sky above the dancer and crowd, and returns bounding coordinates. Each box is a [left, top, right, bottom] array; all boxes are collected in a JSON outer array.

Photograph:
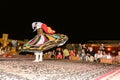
[[0, 0, 120, 43]]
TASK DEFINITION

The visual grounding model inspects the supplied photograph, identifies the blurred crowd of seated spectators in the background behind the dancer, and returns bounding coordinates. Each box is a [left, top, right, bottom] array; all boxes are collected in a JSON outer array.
[[0, 44, 120, 64]]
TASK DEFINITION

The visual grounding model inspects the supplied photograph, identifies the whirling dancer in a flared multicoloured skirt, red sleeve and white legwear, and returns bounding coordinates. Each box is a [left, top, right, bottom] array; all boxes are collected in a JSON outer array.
[[23, 22, 68, 62]]
